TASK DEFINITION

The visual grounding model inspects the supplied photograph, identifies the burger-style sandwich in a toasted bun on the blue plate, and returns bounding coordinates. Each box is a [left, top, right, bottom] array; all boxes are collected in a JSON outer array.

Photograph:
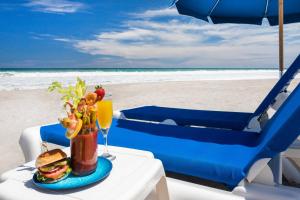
[[35, 149, 72, 183]]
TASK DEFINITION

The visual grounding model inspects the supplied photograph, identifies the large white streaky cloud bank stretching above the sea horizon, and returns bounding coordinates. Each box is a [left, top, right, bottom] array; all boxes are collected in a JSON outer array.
[[52, 8, 300, 67]]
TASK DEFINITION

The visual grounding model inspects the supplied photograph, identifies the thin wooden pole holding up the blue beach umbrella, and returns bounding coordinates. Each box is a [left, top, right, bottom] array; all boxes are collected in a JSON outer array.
[[278, 0, 284, 77]]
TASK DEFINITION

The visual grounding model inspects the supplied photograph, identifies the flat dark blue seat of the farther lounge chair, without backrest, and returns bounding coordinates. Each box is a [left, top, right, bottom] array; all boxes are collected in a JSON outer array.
[[122, 106, 253, 130]]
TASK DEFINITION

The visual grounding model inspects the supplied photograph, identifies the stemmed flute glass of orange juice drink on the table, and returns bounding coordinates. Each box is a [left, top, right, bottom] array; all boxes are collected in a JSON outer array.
[[97, 94, 116, 160]]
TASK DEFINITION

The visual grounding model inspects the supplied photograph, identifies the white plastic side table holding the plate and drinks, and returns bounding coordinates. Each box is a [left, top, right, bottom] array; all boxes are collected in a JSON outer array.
[[0, 145, 169, 200]]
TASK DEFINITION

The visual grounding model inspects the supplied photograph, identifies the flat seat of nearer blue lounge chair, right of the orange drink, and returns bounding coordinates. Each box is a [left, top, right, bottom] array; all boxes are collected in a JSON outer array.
[[109, 120, 259, 186]]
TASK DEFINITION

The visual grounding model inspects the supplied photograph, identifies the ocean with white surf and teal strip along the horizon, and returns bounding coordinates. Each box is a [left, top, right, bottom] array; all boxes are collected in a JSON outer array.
[[0, 68, 279, 90]]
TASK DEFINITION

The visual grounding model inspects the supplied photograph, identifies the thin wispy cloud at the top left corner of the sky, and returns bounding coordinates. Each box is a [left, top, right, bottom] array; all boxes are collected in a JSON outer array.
[[24, 0, 85, 14]]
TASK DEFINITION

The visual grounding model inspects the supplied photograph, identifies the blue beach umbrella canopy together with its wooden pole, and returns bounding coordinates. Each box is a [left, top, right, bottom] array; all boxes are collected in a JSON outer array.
[[174, 0, 300, 75]]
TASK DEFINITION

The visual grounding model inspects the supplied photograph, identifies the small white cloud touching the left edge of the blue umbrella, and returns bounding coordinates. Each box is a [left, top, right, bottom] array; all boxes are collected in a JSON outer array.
[[132, 7, 178, 18]]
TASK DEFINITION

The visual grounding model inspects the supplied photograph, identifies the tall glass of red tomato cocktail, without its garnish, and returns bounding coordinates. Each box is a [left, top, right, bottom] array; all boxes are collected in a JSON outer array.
[[71, 130, 98, 176]]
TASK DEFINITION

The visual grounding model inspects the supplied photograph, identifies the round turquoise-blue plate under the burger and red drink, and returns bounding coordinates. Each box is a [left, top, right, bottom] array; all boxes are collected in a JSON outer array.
[[32, 157, 112, 190]]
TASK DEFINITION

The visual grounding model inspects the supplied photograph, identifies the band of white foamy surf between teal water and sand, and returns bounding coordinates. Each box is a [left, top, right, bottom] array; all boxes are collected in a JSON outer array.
[[0, 70, 300, 91]]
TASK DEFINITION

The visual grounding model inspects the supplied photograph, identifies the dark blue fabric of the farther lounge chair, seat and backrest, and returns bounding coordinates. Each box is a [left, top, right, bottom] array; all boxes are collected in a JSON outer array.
[[121, 55, 300, 130]]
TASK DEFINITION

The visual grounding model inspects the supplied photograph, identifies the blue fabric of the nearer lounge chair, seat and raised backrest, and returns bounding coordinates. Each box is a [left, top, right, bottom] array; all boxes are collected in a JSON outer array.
[[40, 84, 300, 187]]
